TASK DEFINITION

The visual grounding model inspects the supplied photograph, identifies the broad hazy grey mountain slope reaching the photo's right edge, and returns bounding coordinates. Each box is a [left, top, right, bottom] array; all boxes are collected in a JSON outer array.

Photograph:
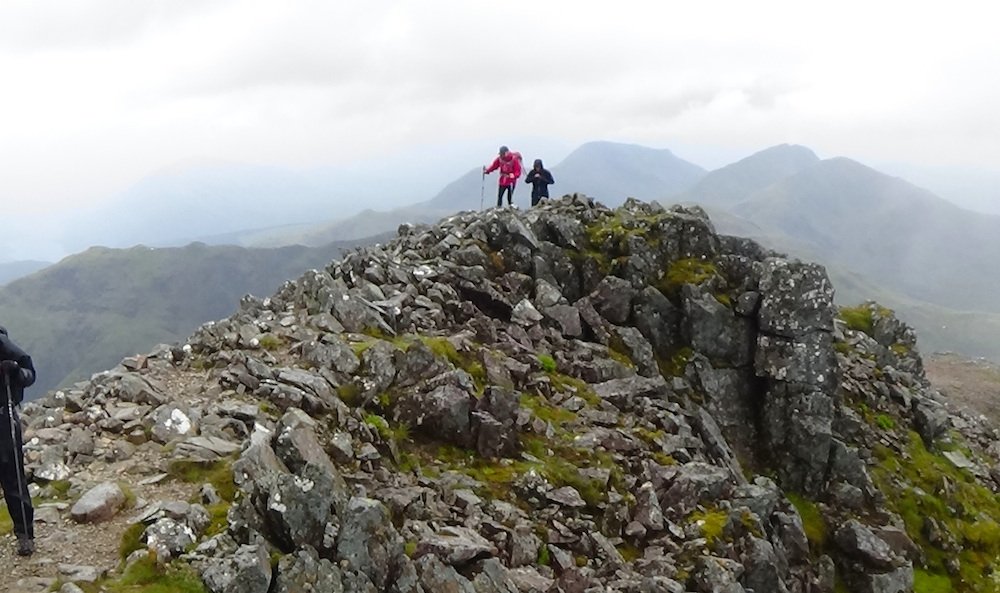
[[733, 158, 1000, 312]]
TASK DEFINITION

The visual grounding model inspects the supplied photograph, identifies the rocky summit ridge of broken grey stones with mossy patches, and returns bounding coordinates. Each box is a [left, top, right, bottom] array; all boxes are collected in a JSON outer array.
[[9, 195, 1000, 593]]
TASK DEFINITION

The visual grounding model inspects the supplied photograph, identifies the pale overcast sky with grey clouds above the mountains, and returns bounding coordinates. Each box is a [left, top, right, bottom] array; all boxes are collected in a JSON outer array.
[[0, 0, 1000, 224]]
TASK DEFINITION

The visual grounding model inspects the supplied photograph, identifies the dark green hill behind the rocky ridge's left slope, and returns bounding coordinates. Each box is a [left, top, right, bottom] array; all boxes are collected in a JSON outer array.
[[0, 236, 382, 394]]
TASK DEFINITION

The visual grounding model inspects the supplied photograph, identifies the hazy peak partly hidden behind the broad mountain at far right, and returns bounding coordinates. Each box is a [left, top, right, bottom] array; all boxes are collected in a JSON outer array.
[[671, 144, 819, 208]]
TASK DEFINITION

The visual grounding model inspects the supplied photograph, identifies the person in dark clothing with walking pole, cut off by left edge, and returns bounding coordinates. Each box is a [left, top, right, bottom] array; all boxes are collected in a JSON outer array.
[[0, 327, 35, 556]]
